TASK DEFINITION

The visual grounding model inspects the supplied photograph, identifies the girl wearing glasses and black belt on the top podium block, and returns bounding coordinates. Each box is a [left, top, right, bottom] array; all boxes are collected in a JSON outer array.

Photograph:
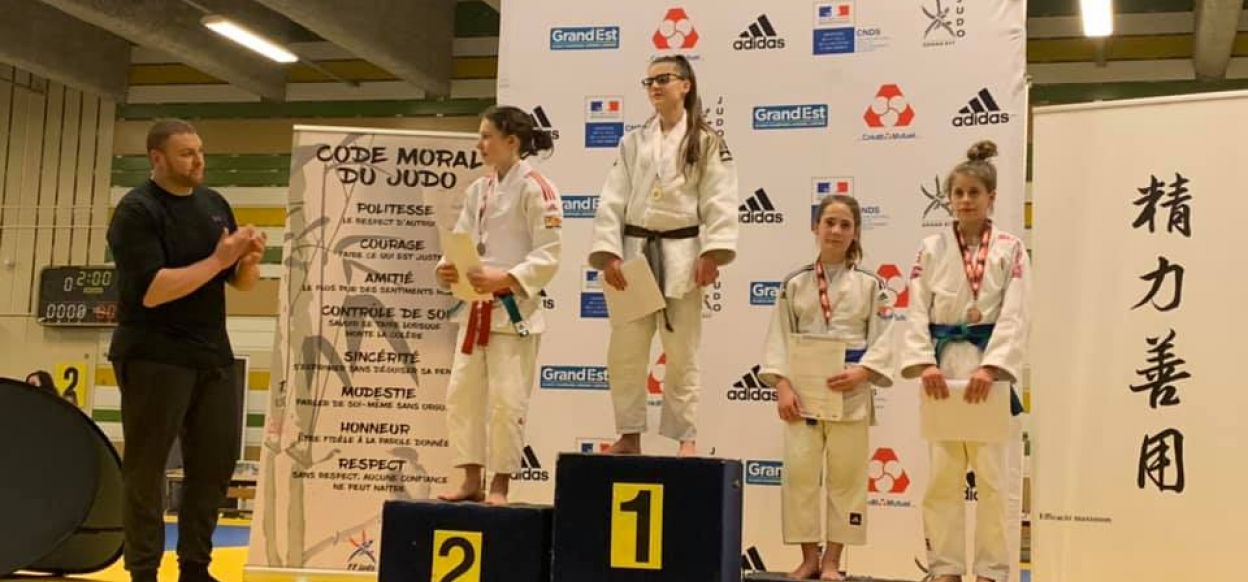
[[589, 56, 738, 456]]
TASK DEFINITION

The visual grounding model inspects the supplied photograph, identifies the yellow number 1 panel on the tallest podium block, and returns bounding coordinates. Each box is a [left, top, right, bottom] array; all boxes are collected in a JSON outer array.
[[612, 483, 663, 570]]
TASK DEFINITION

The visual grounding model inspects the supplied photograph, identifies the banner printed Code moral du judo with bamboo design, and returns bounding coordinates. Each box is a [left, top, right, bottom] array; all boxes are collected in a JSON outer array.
[[248, 126, 482, 571]]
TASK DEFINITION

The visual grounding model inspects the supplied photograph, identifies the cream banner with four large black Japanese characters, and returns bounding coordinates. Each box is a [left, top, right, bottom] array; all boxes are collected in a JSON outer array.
[[1032, 92, 1248, 582]]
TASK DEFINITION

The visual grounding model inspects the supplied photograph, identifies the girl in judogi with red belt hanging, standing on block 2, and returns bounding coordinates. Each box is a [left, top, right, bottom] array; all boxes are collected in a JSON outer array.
[[437, 106, 563, 505]]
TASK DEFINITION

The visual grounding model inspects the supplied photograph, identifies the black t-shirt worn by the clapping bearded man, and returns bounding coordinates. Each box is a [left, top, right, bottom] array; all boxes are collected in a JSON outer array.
[[109, 180, 238, 368]]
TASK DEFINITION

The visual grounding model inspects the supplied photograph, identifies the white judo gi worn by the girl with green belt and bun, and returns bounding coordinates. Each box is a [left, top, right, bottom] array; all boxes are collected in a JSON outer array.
[[900, 227, 1031, 582]]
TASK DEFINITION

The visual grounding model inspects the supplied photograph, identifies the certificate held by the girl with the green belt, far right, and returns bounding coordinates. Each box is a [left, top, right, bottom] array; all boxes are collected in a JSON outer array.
[[919, 380, 1010, 442]]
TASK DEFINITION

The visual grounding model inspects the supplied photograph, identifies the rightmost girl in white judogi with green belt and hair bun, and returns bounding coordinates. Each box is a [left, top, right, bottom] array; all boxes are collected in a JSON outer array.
[[901, 141, 1031, 582]]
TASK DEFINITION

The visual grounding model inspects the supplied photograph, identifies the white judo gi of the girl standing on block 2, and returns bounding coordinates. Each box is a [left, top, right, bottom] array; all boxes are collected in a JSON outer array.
[[434, 160, 563, 473]]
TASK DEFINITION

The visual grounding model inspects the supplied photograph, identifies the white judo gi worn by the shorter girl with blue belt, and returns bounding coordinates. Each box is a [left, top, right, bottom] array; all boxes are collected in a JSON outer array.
[[759, 265, 894, 545]]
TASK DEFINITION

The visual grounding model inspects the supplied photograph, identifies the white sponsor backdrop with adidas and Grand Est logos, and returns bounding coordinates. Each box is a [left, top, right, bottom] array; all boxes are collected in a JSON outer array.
[[498, 0, 1027, 577]]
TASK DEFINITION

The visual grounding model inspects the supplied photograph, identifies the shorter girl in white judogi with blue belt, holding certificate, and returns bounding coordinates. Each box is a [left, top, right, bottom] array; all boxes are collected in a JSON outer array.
[[759, 195, 892, 580]]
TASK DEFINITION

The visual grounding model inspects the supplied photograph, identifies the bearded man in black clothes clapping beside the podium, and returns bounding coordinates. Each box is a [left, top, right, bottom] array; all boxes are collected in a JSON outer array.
[[109, 120, 266, 582]]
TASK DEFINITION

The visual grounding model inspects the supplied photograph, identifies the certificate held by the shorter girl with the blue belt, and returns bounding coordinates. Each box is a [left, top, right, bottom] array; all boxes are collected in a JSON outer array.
[[789, 333, 845, 421]]
